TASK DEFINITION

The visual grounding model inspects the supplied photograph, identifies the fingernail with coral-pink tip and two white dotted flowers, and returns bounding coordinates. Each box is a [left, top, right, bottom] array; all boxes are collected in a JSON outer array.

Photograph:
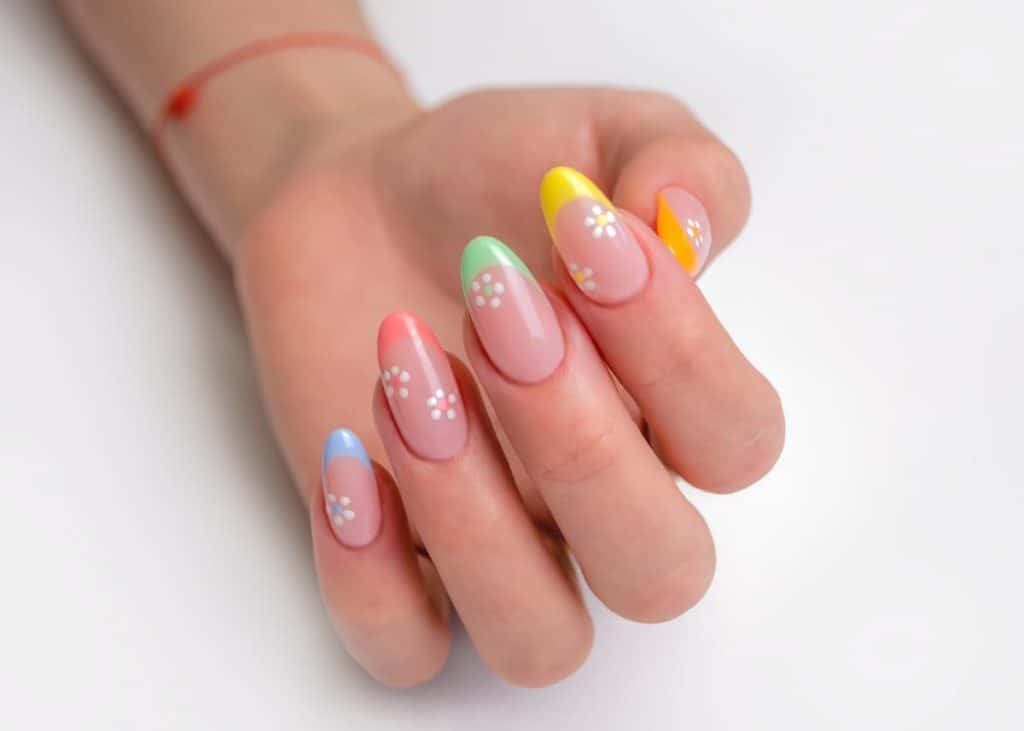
[[377, 312, 467, 461]]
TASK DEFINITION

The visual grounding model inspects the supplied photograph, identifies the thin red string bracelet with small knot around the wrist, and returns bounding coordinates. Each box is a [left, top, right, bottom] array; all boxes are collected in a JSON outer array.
[[152, 33, 401, 151]]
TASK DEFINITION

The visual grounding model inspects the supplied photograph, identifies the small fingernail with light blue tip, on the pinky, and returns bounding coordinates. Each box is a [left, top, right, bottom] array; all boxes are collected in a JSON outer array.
[[322, 429, 381, 548]]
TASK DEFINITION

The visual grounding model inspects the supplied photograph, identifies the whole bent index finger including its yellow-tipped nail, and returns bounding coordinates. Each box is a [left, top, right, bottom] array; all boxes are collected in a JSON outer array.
[[542, 168, 783, 492]]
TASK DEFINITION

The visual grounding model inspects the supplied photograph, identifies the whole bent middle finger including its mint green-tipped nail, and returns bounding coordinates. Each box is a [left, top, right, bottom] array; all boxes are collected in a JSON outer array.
[[462, 237, 714, 621]]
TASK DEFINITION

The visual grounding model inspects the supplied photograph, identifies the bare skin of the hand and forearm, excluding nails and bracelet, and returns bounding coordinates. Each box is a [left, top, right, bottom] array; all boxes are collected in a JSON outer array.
[[62, 0, 783, 687]]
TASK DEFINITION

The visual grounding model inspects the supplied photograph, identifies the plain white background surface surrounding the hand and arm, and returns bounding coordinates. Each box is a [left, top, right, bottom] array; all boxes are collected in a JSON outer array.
[[0, 0, 1024, 731]]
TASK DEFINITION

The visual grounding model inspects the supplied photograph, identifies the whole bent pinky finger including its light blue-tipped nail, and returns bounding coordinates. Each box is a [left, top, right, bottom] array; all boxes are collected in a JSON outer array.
[[310, 429, 451, 687]]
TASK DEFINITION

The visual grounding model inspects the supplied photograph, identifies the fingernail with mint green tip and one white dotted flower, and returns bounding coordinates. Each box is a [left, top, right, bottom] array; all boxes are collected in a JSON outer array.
[[462, 237, 565, 383]]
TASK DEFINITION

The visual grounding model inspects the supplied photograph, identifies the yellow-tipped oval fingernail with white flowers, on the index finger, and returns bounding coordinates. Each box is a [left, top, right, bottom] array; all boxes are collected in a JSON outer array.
[[541, 167, 648, 304]]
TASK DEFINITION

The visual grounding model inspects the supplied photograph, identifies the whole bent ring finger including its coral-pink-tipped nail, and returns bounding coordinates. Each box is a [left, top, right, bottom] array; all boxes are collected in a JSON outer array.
[[374, 312, 593, 686]]
